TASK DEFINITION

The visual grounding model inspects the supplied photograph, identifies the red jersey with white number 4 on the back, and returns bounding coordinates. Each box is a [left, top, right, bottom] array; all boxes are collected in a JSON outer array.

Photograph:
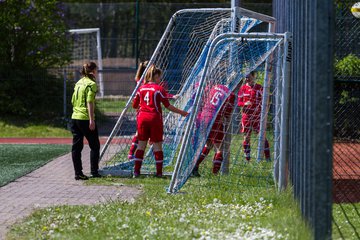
[[133, 83, 170, 114]]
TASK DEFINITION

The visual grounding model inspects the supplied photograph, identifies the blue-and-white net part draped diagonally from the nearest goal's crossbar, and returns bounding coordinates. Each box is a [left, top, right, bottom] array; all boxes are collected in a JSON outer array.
[[169, 34, 282, 192]]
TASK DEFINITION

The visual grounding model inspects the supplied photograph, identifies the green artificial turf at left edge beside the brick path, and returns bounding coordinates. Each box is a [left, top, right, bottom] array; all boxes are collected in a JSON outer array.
[[0, 144, 70, 186]]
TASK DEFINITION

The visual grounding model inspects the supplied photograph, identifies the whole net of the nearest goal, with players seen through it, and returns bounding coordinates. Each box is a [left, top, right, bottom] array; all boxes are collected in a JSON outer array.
[[168, 33, 286, 193]]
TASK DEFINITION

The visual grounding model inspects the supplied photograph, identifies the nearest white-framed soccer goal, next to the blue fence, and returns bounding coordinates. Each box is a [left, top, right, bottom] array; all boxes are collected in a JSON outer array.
[[168, 33, 290, 193]]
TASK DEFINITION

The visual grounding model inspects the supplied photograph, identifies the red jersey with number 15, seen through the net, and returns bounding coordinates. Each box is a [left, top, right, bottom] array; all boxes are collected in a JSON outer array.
[[199, 84, 235, 123]]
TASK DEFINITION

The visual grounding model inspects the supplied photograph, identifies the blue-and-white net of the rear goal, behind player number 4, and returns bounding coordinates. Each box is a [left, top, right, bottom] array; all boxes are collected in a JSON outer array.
[[98, 9, 261, 175]]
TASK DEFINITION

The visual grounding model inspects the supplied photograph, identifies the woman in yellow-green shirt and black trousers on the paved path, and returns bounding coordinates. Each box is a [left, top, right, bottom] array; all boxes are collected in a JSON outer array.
[[71, 62, 101, 180]]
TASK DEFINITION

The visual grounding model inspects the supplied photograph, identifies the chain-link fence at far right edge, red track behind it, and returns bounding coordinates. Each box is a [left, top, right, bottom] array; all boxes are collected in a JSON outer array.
[[333, 0, 360, 239]]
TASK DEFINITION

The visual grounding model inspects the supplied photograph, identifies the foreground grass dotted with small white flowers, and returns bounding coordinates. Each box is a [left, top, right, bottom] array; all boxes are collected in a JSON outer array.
[[8, 172, 311, 239]]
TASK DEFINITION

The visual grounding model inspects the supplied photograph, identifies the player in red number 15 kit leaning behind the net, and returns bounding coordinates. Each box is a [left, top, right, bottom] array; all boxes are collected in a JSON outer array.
[[192, 84, 235, 177]]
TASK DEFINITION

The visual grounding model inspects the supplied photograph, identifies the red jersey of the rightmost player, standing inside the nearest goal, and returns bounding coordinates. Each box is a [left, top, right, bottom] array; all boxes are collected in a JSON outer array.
[[238, 83, 263, 113]]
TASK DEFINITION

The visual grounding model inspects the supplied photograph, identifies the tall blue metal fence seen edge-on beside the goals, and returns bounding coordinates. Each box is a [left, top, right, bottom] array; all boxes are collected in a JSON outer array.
[[273, 0, 334, 239]]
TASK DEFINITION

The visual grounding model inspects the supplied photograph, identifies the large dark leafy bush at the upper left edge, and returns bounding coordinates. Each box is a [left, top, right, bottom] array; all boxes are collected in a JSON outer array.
[[0, 0, 71, 118]]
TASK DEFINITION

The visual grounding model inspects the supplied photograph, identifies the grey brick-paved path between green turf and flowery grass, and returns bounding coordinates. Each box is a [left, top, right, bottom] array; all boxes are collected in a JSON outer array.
[[0, 145, 140, 240]]
